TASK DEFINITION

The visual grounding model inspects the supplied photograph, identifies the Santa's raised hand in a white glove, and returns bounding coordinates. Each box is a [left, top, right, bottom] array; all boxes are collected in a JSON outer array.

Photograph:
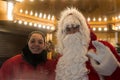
[[88, 41, 119, 76]]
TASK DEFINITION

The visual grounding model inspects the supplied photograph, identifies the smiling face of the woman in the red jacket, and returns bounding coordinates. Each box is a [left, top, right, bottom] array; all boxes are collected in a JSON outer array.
[[28, 33, 45, 54]]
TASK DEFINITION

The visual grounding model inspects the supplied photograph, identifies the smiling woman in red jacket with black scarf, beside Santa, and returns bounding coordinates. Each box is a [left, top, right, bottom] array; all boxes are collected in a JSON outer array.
[[0, 31, 57, 80]]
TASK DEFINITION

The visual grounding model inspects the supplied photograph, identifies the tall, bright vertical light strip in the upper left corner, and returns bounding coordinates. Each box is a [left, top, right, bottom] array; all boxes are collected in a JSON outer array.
[[7, 2, 14, 20]]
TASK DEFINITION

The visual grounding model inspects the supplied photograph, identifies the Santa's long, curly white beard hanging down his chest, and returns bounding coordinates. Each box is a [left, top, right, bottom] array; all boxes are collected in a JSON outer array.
[[56, 33, 88, 80]]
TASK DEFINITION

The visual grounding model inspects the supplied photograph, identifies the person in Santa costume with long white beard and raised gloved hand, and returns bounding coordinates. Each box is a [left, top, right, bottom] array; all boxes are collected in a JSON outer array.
[[56, 8, 120, 80]]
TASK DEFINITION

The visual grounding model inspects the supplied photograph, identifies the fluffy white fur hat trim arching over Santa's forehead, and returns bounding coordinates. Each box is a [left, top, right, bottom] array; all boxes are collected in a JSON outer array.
[[58, 7, 90, 38]]
